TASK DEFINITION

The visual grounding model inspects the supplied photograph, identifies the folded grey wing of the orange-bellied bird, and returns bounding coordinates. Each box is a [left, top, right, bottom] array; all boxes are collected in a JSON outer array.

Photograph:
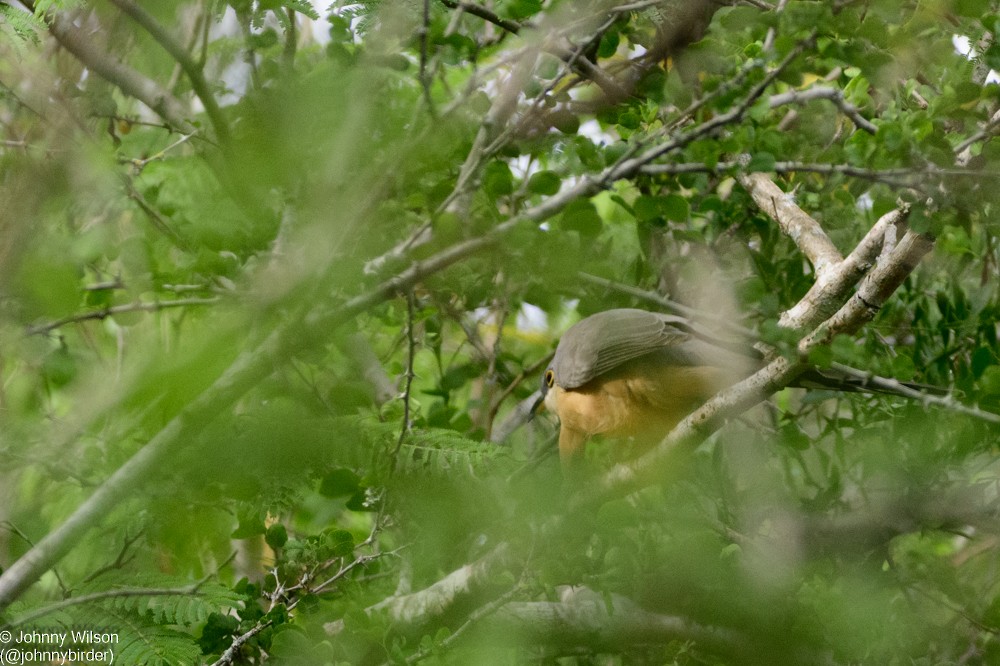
[[551, 308, 711, 389]]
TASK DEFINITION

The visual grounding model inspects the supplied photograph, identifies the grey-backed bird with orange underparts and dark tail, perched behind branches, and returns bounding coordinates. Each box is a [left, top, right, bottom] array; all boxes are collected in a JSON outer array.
[[532, 308, 935, 470]]
